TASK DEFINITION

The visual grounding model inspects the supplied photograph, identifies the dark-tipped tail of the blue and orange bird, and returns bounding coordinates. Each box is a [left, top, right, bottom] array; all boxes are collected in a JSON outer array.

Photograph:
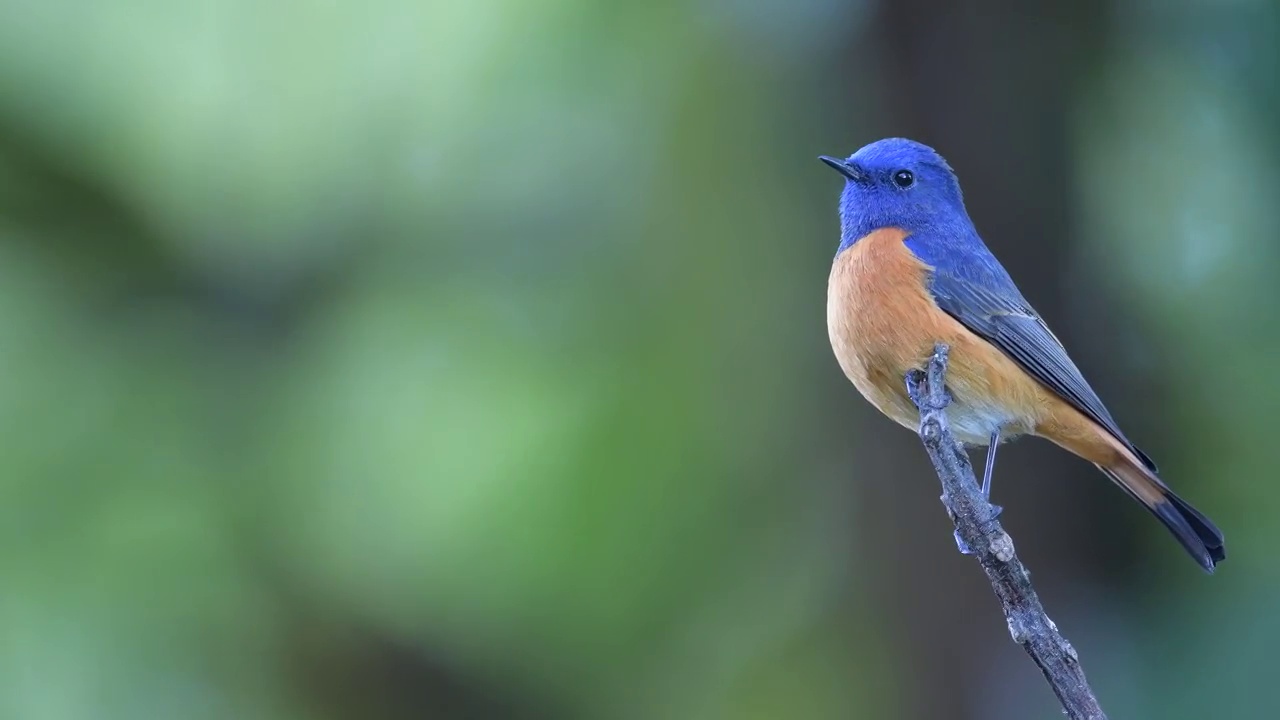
[[1098, 457, 1226, 573]]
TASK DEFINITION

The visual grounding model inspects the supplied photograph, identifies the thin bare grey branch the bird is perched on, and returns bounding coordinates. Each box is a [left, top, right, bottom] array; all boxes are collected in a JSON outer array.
[[908, 343, 1107, 720]]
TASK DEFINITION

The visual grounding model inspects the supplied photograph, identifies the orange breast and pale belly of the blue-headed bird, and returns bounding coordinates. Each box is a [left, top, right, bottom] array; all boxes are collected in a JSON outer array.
[[827, 228, 1065, 445]]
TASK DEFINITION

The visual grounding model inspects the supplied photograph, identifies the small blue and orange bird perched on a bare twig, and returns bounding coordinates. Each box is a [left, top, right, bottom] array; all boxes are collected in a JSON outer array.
[[819, 137, 1226, 573]]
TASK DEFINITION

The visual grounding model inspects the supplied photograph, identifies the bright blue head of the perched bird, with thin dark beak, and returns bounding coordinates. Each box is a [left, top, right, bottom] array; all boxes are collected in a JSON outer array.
[[820, 137, 969, 250]]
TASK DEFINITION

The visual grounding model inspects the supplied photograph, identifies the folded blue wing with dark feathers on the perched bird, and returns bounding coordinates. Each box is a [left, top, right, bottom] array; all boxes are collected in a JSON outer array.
[[906, 230, 1156, 473]]
